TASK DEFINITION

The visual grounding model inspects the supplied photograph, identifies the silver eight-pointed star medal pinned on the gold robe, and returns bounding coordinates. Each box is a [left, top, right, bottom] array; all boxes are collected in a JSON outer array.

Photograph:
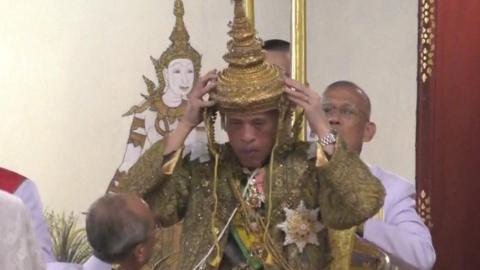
[[277, 200, 325, 253]]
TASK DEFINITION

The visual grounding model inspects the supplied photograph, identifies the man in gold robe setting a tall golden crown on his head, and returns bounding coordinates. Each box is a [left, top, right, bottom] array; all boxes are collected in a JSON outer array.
[[111, 0, 385, 270]]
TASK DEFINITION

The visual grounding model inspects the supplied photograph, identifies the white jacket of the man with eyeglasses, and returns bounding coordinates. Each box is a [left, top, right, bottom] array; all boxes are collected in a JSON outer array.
[[363, 168, 436, 269]]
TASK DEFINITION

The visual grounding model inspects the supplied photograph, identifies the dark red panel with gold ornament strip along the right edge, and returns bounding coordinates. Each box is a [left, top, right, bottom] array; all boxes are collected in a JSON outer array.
[[416, 0, 480, 269]]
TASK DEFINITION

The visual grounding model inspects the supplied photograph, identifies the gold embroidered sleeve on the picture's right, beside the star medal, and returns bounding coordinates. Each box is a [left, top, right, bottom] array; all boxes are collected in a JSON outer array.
[[318, 140, 385, 229]]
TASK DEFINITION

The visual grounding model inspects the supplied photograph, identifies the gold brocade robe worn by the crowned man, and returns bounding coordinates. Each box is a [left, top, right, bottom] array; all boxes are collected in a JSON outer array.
[[113, 140, 385, 270]]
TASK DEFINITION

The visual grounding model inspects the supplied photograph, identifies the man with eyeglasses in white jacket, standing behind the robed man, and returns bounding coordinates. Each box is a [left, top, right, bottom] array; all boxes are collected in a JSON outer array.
[[322, 81, 435, 269]]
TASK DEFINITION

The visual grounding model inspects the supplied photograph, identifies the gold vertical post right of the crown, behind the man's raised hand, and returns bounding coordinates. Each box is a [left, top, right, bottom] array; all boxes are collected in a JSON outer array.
[[290, 0, 307, 141]]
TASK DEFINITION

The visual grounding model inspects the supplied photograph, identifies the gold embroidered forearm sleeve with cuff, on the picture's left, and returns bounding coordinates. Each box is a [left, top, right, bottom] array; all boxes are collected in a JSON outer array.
[[109, 139, 183, 197]]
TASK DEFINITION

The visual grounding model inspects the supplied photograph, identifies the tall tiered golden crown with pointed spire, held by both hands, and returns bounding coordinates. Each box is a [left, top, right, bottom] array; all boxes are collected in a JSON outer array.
[[212, 0, 284, 112]]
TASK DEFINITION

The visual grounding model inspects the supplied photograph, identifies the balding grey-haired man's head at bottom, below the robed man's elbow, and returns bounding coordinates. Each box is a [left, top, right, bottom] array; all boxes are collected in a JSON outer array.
[[84, 193, 155, 270]]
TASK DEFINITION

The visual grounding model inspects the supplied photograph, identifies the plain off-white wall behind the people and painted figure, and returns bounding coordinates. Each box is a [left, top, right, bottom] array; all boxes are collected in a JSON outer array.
[[0, 0, 417, 215]]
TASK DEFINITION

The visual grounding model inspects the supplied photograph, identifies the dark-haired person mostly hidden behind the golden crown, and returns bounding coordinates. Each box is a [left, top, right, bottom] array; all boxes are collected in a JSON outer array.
[[262, 39, 291, 78]]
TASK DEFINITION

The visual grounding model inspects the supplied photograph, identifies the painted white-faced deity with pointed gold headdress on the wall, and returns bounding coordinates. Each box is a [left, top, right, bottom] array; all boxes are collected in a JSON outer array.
[[114, 0, 207, 180]]
